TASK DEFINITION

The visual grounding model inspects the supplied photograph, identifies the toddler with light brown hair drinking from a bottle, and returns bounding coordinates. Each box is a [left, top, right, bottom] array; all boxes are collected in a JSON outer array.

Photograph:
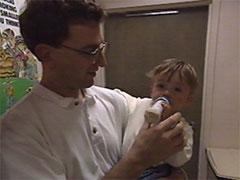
[[122, 58, 198, 180]]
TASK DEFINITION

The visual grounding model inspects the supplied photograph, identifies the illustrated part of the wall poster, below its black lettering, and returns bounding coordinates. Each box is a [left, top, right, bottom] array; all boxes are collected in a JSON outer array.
[[0, 28, 41, 117]]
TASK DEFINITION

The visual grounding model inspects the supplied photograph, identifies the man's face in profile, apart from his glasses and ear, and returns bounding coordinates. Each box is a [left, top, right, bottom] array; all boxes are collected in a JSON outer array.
[[51, 23, 106, 89]]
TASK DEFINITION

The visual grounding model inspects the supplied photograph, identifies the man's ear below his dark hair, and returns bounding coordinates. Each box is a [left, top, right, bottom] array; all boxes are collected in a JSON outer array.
[[35, 44, 52, 62]]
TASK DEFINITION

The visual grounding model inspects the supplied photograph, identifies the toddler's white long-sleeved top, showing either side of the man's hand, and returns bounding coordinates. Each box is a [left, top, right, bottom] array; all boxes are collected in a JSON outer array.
[[122, 97, 193, 167]]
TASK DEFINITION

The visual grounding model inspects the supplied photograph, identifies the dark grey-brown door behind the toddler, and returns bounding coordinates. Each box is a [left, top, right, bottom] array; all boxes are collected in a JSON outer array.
[[104, 6, 208, 179]]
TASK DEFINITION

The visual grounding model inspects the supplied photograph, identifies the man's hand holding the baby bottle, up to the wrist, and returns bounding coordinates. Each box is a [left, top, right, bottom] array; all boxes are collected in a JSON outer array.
[[130, 113, 184, 166]]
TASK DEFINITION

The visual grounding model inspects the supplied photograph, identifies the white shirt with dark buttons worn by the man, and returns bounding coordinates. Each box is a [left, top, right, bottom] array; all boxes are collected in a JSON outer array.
[[0, 85, 129, 180]]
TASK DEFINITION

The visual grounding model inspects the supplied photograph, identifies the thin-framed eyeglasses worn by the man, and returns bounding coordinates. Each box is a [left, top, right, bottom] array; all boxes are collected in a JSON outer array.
[[60, 42, 107, 57]]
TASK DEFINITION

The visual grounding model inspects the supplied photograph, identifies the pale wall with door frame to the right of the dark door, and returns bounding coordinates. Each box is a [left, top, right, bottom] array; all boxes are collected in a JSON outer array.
[[199, 0, 240, 179]]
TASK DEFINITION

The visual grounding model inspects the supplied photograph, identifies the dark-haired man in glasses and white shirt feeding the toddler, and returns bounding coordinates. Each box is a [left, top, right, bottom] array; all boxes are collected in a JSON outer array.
[[1, 0, 184, 180]]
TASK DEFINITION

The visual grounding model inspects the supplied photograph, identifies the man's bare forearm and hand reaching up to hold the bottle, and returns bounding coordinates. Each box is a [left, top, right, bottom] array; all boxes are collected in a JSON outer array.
[[105, 113, 185, 179]]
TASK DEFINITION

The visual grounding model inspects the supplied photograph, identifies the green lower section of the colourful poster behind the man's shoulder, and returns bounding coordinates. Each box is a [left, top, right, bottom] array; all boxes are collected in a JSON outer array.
[[0, 77, 35, 117]]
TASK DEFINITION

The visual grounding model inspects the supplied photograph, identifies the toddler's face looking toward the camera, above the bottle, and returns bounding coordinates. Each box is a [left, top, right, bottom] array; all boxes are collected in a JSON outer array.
[[151, 73, 192, 111]]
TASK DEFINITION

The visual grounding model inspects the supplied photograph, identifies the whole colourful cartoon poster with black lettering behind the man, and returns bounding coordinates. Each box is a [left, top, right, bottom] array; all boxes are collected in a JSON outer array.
[[0, 0, 41, 116]]
